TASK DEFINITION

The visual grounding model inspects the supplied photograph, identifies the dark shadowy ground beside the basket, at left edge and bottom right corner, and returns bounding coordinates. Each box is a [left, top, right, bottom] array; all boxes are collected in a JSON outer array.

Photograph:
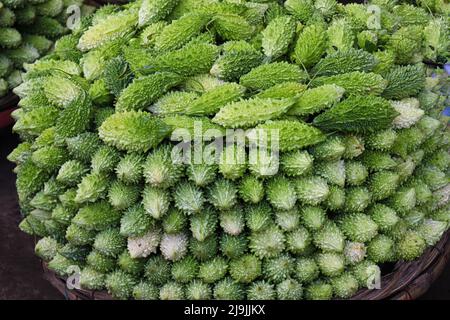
[[0, 128, 450, 300]]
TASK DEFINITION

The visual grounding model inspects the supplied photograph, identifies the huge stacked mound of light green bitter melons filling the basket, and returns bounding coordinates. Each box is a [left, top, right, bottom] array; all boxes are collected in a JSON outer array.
[[9, 0, 450, 299]]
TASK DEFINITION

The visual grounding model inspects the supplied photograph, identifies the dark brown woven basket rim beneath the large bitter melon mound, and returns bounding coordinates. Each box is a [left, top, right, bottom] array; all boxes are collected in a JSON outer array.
[[42, 230, 450, 300]]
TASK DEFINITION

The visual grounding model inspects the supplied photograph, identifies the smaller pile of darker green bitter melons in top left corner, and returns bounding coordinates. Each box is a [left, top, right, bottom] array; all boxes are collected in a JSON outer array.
[[0, 0, 92, 98]]
